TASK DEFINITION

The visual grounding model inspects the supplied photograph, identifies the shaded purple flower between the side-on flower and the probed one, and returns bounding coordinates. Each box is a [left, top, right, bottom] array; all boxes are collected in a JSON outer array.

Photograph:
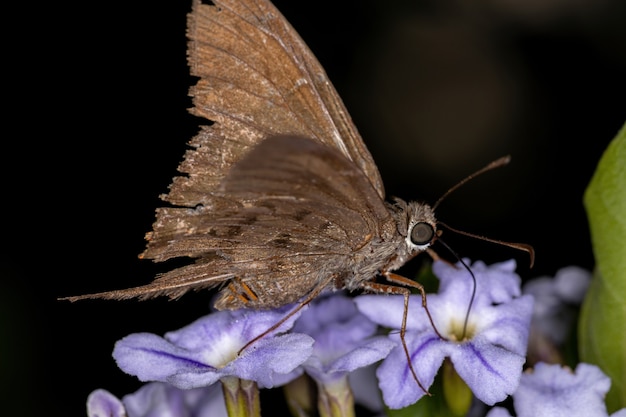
[[293, 295, 395, 383]]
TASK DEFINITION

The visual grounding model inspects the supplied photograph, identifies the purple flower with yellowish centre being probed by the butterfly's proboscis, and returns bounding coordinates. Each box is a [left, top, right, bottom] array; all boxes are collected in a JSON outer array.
[[355, 261, 533, 408]]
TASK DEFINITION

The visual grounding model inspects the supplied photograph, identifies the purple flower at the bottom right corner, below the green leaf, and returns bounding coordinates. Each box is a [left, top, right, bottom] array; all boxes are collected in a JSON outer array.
[[488, 363, 626, 417]]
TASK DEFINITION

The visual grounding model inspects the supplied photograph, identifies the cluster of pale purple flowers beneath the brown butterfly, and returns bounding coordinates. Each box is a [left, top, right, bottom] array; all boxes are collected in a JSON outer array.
[[88, 260, 626, 417]]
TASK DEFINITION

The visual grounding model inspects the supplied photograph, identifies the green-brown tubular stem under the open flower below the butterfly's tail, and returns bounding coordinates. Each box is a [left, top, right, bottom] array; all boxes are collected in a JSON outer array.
[[221, 376, 261, 417]]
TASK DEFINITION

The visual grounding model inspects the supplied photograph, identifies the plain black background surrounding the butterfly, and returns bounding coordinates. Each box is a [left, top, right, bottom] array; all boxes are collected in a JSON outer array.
[[6, 0, 626, 416]]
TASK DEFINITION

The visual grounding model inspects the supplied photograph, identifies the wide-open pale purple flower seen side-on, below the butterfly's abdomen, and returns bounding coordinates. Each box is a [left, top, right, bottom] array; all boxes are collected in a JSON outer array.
[[113, 306, 313, 389]]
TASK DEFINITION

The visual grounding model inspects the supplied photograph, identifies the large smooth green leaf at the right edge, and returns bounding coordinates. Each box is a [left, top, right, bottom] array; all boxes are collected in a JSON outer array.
[[578, 121, 626, 412]]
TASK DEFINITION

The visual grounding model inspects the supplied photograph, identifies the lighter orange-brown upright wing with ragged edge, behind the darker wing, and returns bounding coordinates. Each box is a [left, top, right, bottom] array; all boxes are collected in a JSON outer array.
[[163, 0, 384, 207]]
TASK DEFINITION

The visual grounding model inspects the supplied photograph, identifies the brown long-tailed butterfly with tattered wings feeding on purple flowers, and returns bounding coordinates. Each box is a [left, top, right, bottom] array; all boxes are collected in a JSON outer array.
[[65, 0, 528, 383]]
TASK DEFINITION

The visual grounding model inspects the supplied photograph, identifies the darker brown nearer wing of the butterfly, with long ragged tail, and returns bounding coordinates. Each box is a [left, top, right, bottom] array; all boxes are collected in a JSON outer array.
[[70, 136, 395, 309]]
